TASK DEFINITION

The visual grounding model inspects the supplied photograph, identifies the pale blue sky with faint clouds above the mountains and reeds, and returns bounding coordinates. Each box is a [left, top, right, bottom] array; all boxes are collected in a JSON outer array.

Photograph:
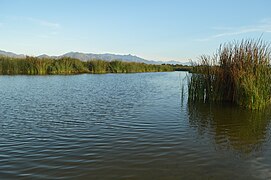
[[0, 0, 271, 61]]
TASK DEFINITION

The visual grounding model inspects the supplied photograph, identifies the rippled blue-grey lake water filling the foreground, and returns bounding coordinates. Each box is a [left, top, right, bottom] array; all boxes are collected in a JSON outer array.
[[0, 72, 271, 179]]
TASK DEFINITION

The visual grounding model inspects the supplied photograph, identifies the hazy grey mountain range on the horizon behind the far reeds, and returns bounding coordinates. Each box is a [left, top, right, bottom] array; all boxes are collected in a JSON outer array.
[[0, 50, 188, 65]]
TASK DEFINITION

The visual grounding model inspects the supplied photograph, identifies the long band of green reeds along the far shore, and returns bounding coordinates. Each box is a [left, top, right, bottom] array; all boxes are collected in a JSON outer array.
[[0, 56, 173, 75]]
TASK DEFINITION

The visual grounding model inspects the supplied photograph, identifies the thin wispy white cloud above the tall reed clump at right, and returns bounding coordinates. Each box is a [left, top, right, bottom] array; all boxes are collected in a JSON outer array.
[[196, 18, 271, 41]]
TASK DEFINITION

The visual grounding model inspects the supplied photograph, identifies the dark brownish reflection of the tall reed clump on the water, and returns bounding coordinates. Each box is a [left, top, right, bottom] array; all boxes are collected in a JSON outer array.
[[188, 104, 271, 155]]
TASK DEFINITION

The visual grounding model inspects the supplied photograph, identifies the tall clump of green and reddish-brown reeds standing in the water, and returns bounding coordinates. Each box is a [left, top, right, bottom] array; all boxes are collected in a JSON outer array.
[[188, 39, 271, 110]]
